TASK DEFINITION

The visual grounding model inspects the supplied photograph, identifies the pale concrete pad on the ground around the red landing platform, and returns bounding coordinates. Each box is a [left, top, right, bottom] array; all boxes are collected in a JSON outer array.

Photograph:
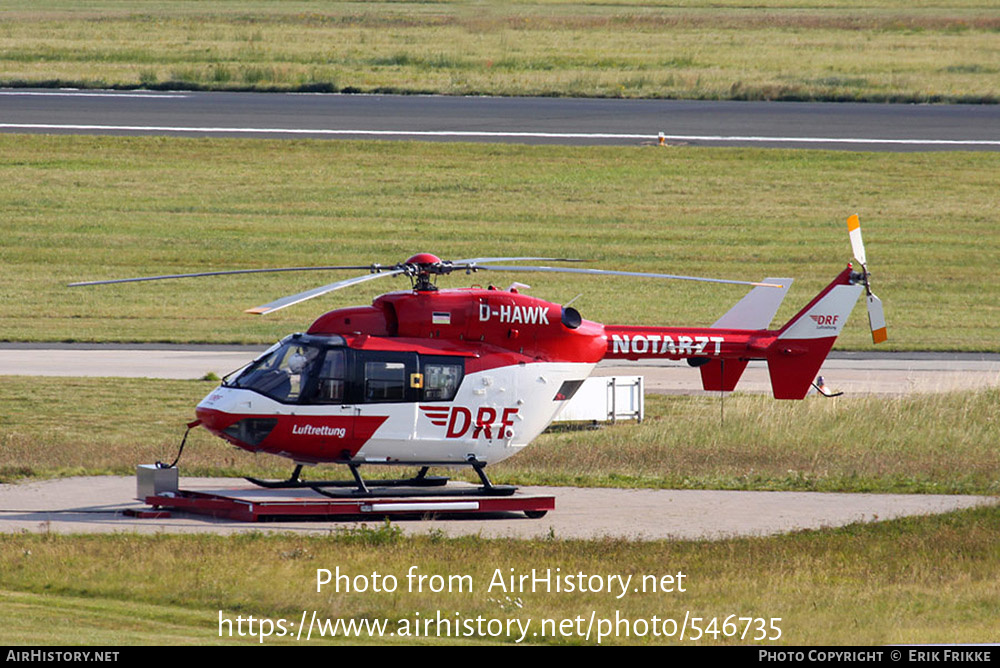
[[0, 470, 1000, 540]]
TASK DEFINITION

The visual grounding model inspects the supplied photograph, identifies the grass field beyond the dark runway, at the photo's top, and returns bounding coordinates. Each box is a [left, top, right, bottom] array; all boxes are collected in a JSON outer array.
[[0, 0, 1000, 103]]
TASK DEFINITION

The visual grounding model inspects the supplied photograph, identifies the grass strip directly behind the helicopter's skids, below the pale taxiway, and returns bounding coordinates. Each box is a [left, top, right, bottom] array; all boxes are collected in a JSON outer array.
[[0, 376, 1000, 494]]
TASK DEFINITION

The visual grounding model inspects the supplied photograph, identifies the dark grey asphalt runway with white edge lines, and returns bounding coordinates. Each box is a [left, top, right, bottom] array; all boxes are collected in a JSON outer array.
[[0, 89, 1000, 151]]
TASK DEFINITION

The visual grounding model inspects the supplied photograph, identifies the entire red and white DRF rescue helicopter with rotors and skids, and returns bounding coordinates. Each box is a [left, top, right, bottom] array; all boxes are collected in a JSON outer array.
[[73, 215, 886, 494]]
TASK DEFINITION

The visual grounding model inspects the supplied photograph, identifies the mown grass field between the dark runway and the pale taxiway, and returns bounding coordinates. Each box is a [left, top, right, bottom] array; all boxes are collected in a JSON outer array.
[[0, 135, 1000, 351]]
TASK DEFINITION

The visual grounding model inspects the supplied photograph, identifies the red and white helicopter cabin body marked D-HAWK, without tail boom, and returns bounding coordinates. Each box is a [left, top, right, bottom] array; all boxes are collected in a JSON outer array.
[[196, 289, 607, 465]]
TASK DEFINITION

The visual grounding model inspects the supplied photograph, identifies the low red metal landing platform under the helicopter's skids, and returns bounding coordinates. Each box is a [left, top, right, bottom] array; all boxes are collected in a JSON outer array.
[[142, 483, 555, 522]]
